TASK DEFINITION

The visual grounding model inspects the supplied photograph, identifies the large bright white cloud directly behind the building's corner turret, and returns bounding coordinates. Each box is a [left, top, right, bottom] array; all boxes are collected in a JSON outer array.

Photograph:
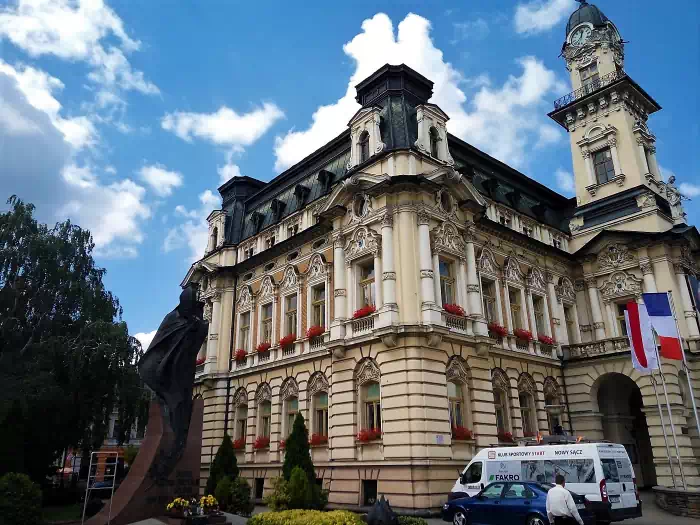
[[275, 13, 565, 171]]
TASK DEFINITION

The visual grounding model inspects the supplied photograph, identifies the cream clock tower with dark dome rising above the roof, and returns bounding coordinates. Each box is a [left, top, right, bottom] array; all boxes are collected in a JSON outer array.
[[549, 0, 685, 247]]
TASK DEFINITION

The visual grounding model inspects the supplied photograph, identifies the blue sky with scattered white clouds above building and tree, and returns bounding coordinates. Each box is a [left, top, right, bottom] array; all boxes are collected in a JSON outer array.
[[0, 0, 700, 348]]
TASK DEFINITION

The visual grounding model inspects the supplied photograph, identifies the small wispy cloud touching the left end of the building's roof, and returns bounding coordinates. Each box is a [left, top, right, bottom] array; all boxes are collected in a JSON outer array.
[[163, 190, 221, 262]]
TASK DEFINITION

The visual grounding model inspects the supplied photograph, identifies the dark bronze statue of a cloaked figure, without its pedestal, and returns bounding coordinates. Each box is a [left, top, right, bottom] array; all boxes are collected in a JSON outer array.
[[138, 284, 209, 477]]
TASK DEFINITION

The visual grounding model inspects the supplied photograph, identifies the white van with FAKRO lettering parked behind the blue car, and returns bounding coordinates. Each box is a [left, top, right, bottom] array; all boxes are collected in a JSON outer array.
[[448, 443, 642, 523]]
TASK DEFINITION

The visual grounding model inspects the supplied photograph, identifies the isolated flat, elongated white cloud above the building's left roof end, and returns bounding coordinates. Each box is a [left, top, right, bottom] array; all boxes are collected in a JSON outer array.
[[161, 102, 284, 149]]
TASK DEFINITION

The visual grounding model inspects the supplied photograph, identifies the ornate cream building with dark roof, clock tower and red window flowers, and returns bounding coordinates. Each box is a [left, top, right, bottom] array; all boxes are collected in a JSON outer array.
[[182, 2, 700, 509]]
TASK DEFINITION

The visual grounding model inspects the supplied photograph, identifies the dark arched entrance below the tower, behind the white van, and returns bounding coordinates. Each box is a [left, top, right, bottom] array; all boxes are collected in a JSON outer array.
[[591, 372, 656, 487]]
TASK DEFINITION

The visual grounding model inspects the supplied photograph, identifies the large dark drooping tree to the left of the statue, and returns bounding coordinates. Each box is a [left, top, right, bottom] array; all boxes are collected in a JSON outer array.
[[0, 197, 143, 480]]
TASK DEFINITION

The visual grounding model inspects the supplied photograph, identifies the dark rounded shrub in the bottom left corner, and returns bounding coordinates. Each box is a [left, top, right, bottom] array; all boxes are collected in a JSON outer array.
[[0, 472, 41, 525]]
